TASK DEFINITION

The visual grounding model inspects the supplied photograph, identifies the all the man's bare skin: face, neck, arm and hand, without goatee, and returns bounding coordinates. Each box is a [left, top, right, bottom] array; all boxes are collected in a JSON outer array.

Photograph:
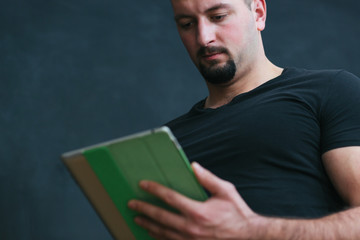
[[129, 0, 360, 240]]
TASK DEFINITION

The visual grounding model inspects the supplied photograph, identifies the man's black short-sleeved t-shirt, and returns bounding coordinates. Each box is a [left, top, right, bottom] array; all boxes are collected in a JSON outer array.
[[167, 68, 360, 218]]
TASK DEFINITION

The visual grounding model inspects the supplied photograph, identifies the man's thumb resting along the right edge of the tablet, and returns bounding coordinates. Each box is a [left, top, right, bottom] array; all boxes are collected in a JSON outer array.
[[191, 162, 231, 195]]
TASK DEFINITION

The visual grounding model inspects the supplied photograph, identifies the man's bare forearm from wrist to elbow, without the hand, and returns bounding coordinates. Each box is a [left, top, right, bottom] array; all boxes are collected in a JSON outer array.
[[256, 207, 360, 240]]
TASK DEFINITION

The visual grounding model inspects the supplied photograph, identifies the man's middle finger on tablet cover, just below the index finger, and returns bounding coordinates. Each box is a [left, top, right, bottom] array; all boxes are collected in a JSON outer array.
[[128, 200, 186, 230]]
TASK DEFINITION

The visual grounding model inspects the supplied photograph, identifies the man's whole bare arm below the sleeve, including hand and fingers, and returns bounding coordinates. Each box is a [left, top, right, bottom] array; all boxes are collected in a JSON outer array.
[[129, 147, 360, 240]]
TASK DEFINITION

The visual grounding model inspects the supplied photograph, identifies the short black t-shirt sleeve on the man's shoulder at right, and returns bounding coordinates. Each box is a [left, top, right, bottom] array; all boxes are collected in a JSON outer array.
[[320, 71, 360, 153]]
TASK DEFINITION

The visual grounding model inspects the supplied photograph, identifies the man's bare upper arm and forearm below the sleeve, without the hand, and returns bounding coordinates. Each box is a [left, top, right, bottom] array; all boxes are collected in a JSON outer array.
[[258, 147, 360, 240]]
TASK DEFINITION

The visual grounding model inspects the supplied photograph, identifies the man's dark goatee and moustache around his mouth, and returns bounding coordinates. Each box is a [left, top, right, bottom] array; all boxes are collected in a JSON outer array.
[[198, 47, 236, 84]]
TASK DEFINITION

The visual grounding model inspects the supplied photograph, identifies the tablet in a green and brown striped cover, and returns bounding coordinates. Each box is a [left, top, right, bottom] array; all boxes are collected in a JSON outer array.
[[62, 127, 207, 240]]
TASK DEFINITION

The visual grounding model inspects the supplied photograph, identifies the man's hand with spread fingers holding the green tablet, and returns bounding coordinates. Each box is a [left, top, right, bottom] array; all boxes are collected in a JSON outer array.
[[129, 163, 264, 240]]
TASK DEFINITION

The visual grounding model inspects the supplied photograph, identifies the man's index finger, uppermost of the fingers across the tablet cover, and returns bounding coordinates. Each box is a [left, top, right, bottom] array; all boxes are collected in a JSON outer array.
[[140, 181, 200, 216]]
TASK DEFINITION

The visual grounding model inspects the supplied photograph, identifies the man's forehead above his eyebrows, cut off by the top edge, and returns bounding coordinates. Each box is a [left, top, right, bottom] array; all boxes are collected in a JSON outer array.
[[171, 0, 244, 15]]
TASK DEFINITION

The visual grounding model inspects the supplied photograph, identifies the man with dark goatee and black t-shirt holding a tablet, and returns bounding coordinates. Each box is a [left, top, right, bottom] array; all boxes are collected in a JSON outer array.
[[129, 0, 360, 240]]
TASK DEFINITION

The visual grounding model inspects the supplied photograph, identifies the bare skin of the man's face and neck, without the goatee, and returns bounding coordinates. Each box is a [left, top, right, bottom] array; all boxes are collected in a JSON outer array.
[[172, 0, 282, 108]]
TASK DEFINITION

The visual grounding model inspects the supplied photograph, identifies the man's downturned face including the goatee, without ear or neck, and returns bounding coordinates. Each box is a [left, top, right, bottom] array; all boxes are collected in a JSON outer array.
[[172, 0, 259, 84]]
